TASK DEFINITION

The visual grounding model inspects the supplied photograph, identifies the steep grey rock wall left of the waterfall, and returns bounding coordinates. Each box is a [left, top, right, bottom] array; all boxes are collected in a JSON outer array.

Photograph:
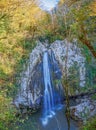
[[14, 42, 46, 108]]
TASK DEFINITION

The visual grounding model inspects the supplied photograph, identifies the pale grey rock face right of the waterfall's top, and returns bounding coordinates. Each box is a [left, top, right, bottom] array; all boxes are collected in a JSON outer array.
[[50, 39, 86, 87]]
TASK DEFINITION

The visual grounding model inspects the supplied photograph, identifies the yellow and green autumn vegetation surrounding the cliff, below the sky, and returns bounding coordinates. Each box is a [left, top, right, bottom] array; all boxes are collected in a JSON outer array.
[[0, 0, 96, 130]]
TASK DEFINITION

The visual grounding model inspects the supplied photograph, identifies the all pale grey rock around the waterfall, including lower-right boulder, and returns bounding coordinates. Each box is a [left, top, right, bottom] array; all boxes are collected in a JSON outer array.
[[14, 39, 96, 124]]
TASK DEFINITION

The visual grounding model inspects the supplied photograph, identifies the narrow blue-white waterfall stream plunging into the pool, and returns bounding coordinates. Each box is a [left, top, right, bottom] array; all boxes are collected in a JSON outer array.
[[43, 51, 55, 124]]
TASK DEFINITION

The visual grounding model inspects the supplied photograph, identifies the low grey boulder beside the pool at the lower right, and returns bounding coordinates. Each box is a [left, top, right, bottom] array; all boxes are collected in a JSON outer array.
[[70, 98, 96, 122]]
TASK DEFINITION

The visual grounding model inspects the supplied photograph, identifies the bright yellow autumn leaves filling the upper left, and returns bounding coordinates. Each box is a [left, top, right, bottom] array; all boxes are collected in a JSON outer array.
[[0, 0, 43, 74]]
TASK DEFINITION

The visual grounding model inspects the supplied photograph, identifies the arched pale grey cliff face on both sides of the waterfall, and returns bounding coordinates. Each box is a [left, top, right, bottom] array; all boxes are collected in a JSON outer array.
[[14, 40, 85, 108]]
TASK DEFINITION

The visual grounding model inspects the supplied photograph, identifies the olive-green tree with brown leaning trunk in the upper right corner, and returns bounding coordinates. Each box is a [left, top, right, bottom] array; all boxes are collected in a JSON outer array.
[[59, 0, 96, 58]]
